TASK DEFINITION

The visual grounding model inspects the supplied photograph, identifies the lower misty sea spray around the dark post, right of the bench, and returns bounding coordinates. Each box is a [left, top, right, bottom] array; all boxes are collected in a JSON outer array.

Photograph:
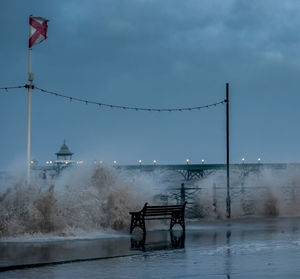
[[194, 166, 300, 219]]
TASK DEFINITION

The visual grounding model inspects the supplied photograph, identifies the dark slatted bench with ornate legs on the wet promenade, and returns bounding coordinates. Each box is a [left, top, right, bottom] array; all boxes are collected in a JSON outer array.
[[129, 202, 187, 233]]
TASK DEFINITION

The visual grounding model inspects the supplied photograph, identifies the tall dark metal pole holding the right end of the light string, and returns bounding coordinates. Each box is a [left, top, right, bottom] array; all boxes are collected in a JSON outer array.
[[226, 83, 231, 218]]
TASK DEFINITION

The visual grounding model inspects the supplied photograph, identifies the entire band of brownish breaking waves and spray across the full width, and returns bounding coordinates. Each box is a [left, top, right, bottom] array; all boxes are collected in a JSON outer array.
[[0, 166, 300, 239]]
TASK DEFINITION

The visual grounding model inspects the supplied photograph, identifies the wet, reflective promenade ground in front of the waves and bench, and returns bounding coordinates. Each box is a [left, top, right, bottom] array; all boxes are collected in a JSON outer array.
[[0, 217, 300, 279]]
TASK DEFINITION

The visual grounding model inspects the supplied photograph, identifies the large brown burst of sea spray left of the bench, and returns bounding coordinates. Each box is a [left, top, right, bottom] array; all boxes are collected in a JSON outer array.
[[0, 167, 159, 237]]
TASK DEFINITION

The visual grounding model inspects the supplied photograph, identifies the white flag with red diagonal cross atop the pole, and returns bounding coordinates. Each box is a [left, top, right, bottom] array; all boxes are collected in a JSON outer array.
[[29, 17, 48, 48]]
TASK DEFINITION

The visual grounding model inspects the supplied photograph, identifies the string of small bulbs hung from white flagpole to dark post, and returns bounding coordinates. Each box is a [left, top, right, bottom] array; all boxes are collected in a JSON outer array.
[[0, 85, 226, 112]]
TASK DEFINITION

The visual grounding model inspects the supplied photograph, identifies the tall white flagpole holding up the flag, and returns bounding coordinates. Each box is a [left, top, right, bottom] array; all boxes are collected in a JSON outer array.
[[26, 15, 33, 185]]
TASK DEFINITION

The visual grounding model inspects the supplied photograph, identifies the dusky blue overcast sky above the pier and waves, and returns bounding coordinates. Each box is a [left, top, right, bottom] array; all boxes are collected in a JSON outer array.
[[0, 0, 300, 170]]
